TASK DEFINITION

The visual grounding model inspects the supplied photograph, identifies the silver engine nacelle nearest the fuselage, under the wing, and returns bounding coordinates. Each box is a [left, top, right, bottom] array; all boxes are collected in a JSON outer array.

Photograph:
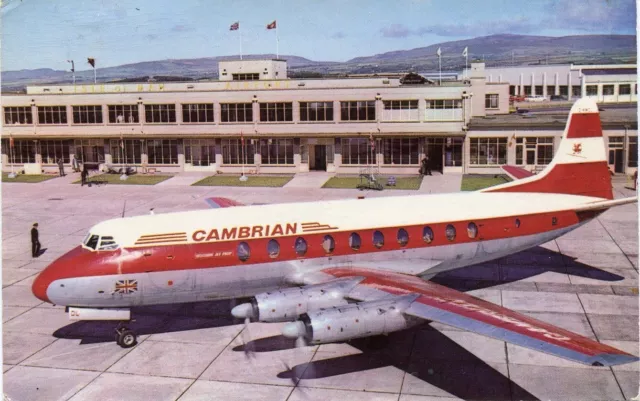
[[231, 277, 363, 322]]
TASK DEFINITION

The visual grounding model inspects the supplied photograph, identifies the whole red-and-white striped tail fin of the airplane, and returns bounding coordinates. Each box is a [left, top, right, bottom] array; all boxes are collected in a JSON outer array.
[[482, 98, 613, 199]]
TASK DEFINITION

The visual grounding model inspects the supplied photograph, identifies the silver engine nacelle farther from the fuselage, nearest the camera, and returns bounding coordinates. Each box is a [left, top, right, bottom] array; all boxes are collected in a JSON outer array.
[[282, 294, 422, 344]]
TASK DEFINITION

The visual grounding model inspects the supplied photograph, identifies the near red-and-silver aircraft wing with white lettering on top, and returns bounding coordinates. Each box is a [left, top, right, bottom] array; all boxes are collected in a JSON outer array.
[[315, 267, 639, 366]]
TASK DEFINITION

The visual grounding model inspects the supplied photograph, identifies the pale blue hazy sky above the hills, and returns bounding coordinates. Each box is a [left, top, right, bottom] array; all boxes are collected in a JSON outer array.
[[0, 0, 636, 71]]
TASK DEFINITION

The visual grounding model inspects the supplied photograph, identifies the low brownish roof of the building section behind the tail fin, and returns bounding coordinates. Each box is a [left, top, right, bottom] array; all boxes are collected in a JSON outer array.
[[469, 103, 638, 131]]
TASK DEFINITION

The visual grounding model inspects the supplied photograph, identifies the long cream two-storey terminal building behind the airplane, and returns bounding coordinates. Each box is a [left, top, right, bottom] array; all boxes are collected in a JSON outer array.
[[2, 60, 637, 174]]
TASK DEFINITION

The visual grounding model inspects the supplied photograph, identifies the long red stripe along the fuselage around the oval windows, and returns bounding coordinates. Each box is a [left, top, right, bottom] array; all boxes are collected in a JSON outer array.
[[36, 210, 579, 281]]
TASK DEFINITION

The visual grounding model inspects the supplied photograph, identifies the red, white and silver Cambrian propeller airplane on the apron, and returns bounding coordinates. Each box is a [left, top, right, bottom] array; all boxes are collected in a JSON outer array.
[[32, 98, 639, 366]]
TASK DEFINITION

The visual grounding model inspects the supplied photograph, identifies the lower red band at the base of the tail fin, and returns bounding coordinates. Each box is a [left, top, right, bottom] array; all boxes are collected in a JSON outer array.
[[486, 161, 613, 199]]
